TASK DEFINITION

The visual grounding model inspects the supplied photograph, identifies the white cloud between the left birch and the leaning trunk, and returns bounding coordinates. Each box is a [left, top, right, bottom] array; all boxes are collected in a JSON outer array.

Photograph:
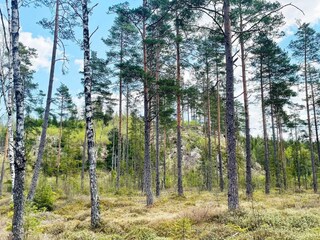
[[20, 32, 52, 70]]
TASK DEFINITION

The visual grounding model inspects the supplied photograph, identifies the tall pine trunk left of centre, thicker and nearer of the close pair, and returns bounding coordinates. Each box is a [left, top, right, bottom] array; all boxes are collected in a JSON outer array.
[[142, 0, 153, 206]]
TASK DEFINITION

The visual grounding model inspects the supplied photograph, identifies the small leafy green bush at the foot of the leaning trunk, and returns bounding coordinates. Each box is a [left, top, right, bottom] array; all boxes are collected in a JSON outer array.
[[33, 182, 55, 211]]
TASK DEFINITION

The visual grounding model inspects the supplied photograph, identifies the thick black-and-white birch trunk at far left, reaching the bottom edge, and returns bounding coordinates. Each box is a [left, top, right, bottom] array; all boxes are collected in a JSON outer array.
[[11, 0, 26, 236]]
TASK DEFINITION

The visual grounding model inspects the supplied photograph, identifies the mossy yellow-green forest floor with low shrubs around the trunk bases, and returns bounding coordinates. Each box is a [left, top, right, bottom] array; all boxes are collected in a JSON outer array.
[[0, 191, 320, 240]]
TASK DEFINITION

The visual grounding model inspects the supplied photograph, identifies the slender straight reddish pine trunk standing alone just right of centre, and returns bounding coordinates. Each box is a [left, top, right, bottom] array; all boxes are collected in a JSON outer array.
[[176, 15, 183, 196]]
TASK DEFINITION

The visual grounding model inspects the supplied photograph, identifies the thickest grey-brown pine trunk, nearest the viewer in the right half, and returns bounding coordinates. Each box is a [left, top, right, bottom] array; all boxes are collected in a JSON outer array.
[[223, 0, 239, 210]]
